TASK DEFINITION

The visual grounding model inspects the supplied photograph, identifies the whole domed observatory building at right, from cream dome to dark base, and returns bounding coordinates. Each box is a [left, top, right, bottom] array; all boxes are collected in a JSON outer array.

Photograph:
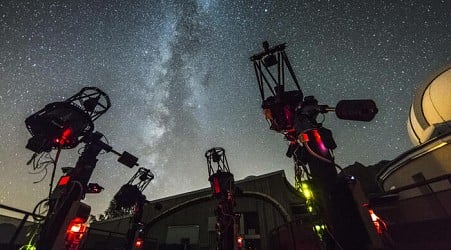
[[377, 68, 451, 249]]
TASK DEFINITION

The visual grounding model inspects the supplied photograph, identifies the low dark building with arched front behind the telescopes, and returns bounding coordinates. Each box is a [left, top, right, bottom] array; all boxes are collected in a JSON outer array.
[[87, 170, 305, 249]]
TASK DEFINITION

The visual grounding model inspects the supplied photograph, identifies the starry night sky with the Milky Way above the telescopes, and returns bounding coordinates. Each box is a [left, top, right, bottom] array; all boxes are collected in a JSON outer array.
[[0, 0, 451, 218]]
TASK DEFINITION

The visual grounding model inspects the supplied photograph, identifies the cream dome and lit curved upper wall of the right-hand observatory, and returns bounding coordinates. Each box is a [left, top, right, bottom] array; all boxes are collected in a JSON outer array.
[[378, 68, 451, 195]]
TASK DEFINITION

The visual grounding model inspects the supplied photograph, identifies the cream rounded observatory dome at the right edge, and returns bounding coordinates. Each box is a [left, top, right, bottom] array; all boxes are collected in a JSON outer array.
[[407, 67, 451, 145]]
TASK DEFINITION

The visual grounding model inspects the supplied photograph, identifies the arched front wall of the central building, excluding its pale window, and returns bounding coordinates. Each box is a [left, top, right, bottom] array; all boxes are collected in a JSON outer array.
[[144, 171, 304, 249]]
